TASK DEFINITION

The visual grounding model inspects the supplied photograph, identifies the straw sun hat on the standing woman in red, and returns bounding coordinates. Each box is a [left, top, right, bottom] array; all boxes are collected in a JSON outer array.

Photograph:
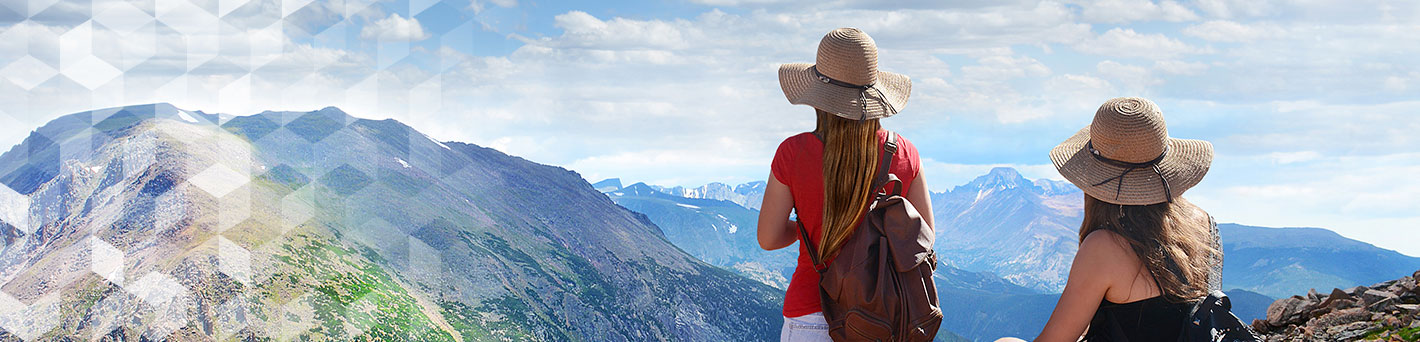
[[780, 28, 912, 121]]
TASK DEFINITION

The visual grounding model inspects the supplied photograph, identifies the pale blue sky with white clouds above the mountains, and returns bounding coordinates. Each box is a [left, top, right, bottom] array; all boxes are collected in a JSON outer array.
[[0, 0, 1420, 255]]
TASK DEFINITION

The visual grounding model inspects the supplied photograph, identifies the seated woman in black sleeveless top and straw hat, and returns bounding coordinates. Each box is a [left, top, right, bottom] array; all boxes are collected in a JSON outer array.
[[1035, 98, 1223, 341]]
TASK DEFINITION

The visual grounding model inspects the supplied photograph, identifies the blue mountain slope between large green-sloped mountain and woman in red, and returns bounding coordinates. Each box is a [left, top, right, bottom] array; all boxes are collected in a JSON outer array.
[[599, 182, 798, 289]]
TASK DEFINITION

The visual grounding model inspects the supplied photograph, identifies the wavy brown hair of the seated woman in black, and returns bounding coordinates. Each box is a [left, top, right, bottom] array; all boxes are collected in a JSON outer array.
[[1079, 194, 1223, 302]]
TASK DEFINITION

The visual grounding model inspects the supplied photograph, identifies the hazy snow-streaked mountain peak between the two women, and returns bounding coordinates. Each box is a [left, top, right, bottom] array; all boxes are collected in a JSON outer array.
[[932, 167, 1083, 292]]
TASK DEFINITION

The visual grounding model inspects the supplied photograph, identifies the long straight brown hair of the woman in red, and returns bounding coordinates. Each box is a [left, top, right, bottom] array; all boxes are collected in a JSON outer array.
[[814, 109, 882, 260]]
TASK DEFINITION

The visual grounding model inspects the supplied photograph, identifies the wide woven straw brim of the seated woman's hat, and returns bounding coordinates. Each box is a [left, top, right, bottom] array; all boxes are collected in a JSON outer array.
[[1051, 126, 1213, 206]]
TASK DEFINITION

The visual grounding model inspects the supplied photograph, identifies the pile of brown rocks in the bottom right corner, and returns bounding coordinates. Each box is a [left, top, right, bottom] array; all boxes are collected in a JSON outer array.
[[1252, 271, 1420, 341]]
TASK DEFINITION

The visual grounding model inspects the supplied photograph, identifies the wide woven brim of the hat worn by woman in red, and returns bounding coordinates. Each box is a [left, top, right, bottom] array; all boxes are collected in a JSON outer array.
[[780, 62, 912, 119]]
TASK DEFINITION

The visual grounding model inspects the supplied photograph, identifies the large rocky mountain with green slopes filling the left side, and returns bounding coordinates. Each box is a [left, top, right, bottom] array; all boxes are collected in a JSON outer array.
[[0, 104, 782, 341]]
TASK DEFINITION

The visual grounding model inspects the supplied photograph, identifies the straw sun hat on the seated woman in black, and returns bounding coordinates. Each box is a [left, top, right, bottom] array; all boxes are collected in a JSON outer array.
[[1051, 98, 1213, 206]]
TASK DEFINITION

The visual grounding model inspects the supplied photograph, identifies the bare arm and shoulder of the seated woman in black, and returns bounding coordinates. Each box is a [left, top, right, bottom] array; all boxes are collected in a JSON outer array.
[[1035, 230, 1135, 342]]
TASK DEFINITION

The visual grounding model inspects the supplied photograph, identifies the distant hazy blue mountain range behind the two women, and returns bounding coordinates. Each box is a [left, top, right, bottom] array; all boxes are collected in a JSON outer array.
[[616, 167, 1420, 341]]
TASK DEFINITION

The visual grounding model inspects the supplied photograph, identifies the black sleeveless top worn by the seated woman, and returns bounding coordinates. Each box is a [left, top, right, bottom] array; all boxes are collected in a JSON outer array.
[[1085, 295, 1193, 342]]
